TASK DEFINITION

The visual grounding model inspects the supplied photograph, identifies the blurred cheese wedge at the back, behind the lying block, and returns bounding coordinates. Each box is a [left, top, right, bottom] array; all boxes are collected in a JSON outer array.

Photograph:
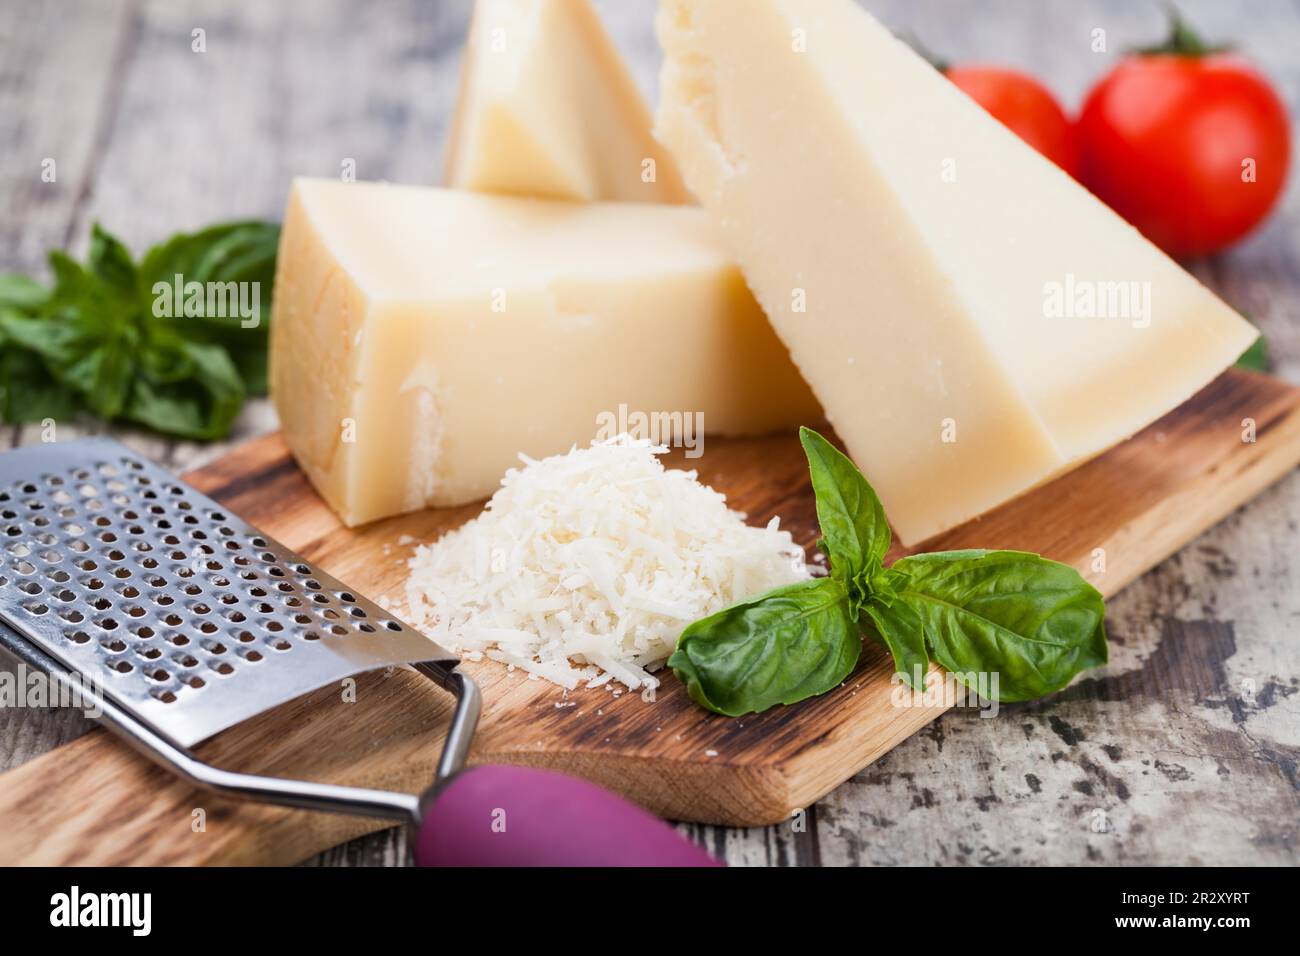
[[446, 0, 690, 203]]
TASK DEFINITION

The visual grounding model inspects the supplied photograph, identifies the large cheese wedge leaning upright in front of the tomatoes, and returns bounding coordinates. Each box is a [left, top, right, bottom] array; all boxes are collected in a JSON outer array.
[[657, 0, 1256, 544]]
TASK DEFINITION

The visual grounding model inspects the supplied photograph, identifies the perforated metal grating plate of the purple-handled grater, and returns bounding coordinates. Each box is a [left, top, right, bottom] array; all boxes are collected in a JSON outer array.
[[0, 438, 458, 747]]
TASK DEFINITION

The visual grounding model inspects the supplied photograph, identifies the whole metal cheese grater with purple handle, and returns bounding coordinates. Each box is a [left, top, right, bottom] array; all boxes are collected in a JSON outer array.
[[0, 438, 714, 866]]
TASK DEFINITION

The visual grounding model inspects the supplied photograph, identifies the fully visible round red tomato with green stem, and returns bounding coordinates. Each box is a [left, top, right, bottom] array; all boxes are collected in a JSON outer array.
[[1079, 52, 1291, 258]]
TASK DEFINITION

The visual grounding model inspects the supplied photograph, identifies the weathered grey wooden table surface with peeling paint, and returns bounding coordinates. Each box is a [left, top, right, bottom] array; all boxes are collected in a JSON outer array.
[[0, 0, 1300, 865]]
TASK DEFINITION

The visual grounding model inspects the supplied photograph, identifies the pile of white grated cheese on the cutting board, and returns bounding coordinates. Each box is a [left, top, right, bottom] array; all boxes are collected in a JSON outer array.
[[407, 436, 809, 689]]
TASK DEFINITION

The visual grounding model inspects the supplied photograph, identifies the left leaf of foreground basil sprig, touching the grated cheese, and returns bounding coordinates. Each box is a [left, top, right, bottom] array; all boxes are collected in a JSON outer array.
[[668, 578, 862, 717]]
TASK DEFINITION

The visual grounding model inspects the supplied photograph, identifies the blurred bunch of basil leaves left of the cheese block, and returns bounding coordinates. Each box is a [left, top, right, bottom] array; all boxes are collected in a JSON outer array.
[[0, 221, 280, 441]]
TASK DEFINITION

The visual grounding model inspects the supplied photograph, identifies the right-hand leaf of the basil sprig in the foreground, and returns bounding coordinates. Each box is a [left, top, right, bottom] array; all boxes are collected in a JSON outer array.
[[892, 550, 1106, 701]]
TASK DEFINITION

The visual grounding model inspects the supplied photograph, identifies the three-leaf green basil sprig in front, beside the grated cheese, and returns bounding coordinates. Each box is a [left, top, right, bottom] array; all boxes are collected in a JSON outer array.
[[668, 428, 1106, 717]]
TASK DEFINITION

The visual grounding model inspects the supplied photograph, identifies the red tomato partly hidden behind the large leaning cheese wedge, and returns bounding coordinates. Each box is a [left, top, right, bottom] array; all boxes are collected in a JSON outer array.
[[944, 66, 1079, 176]]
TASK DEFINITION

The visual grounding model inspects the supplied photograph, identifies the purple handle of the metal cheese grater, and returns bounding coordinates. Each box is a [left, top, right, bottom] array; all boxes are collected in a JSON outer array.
[[415, 766, 719, 866]]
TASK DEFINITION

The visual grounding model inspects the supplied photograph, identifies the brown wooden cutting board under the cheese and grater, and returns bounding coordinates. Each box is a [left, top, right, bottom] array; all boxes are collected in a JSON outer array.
[[0, 371, 1300, 864]]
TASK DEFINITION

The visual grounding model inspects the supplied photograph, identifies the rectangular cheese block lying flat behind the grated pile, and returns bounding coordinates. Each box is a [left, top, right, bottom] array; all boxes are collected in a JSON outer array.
[[270, 179, 820, 524]]
